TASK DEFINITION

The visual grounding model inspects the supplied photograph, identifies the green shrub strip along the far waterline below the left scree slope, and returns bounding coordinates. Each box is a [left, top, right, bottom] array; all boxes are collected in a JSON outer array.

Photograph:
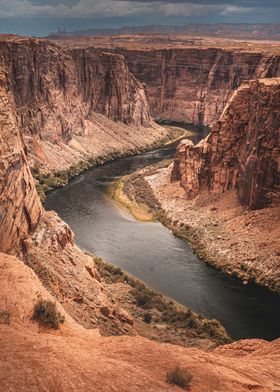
[[31, 127, 186, 202]]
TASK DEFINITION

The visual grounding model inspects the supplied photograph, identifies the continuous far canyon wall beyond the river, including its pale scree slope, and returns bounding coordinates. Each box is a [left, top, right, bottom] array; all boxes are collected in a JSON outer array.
[[0, 36, 280, 171]]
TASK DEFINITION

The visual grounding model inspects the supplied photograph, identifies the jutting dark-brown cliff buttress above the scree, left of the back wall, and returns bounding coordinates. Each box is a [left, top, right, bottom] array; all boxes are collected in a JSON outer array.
[[71, 49, 151, 126]]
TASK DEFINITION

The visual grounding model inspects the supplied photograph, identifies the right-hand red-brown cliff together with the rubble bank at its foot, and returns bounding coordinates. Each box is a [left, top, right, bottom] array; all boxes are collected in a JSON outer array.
[[121, 78, 280, 293]]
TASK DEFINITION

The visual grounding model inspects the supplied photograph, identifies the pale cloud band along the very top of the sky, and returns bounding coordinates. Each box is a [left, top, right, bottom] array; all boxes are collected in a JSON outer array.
[[0, 0, 280, 18]]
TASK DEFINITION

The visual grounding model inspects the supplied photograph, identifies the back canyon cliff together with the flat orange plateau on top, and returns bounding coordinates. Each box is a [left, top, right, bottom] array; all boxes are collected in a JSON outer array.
[[54, 34, 280, 125]]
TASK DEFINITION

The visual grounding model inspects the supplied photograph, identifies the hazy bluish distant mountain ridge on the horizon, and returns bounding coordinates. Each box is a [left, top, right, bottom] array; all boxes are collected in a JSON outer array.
[[48, 23, 280, 40]]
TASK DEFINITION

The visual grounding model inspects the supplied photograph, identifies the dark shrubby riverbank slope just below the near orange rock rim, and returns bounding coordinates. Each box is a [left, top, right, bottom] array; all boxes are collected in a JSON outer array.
[[88, 252, 233, 350]]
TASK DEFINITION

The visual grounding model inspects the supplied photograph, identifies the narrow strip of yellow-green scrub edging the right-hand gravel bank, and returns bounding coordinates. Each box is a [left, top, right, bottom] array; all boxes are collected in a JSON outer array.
[[113, 161, 280, 294]]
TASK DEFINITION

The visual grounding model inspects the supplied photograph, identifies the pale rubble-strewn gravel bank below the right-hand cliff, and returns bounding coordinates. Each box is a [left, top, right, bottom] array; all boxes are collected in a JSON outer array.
[[117, 161, 280, 292]]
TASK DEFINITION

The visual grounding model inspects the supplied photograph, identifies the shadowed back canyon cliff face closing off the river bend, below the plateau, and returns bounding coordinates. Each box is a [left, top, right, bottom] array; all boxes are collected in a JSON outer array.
[[115, 47, 280, 125]]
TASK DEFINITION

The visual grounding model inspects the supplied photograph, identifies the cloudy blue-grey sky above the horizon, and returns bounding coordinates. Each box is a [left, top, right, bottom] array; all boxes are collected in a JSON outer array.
[[0, 0, 280, 36]]
